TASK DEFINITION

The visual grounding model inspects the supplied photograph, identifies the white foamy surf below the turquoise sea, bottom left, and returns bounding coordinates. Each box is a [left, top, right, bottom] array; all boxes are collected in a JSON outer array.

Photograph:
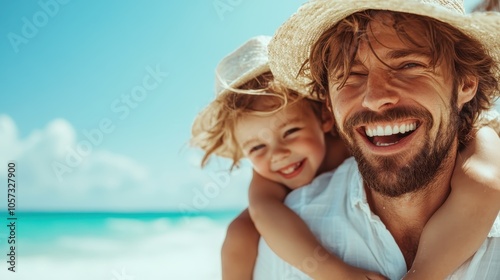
[[0, 217, 227, 280]]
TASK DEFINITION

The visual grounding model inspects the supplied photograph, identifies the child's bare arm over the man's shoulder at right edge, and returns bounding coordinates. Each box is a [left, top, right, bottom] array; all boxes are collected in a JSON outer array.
[[404, 127, 500, 279]]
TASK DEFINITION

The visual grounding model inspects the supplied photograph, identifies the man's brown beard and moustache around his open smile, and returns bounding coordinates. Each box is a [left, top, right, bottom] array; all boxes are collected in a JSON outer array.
[[341, 106, 459, 197]]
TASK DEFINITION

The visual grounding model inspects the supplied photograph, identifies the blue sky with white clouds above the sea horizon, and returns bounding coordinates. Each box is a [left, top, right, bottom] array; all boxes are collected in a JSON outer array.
[[0, 0, 492, 211]]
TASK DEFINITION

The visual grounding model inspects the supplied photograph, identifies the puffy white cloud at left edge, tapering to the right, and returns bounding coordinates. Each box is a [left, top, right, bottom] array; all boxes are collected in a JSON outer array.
[[0, 116, 148, 193]]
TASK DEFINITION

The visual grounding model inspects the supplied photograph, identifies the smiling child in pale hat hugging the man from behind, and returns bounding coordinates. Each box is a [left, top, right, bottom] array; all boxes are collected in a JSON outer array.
[[193, 37, 500, 279]]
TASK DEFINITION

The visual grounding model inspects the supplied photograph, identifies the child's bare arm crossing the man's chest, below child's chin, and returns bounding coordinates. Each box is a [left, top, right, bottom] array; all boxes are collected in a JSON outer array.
[[249, 172, 386, 280]]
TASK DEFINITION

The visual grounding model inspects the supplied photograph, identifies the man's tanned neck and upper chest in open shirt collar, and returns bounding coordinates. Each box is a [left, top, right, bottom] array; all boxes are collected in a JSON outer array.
[[366, 149, 456, 268]]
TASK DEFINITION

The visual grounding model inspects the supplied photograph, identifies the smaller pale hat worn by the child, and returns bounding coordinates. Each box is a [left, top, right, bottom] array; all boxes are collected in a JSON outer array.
[[191, 36, 271, 157]]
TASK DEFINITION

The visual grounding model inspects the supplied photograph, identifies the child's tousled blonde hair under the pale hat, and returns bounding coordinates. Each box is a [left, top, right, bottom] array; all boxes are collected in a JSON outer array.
[[191, 72, 324, 169]]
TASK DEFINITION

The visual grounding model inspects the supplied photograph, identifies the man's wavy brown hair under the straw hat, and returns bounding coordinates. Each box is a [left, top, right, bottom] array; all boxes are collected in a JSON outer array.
[[299, 10, 498, 149]]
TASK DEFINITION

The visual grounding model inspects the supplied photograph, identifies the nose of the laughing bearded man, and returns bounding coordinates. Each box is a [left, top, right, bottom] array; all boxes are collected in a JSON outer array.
[[363, 70, 400, 111]]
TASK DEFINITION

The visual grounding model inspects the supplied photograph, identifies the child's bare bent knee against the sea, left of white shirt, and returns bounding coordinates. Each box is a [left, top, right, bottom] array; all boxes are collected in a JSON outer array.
[[221, 209, 260, 280]]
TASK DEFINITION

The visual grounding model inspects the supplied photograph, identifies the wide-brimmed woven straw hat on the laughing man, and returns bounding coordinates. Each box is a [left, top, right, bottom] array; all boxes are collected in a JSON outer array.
[[269, 0, 500, 94]]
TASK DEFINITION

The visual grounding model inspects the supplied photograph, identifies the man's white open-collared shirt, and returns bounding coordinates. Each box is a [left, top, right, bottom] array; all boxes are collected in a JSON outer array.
[[254, 158, 500, 280]]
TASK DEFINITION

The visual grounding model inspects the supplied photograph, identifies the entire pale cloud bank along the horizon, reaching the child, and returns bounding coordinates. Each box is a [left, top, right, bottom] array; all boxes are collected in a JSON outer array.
[[0, 115, 250, 211]]
